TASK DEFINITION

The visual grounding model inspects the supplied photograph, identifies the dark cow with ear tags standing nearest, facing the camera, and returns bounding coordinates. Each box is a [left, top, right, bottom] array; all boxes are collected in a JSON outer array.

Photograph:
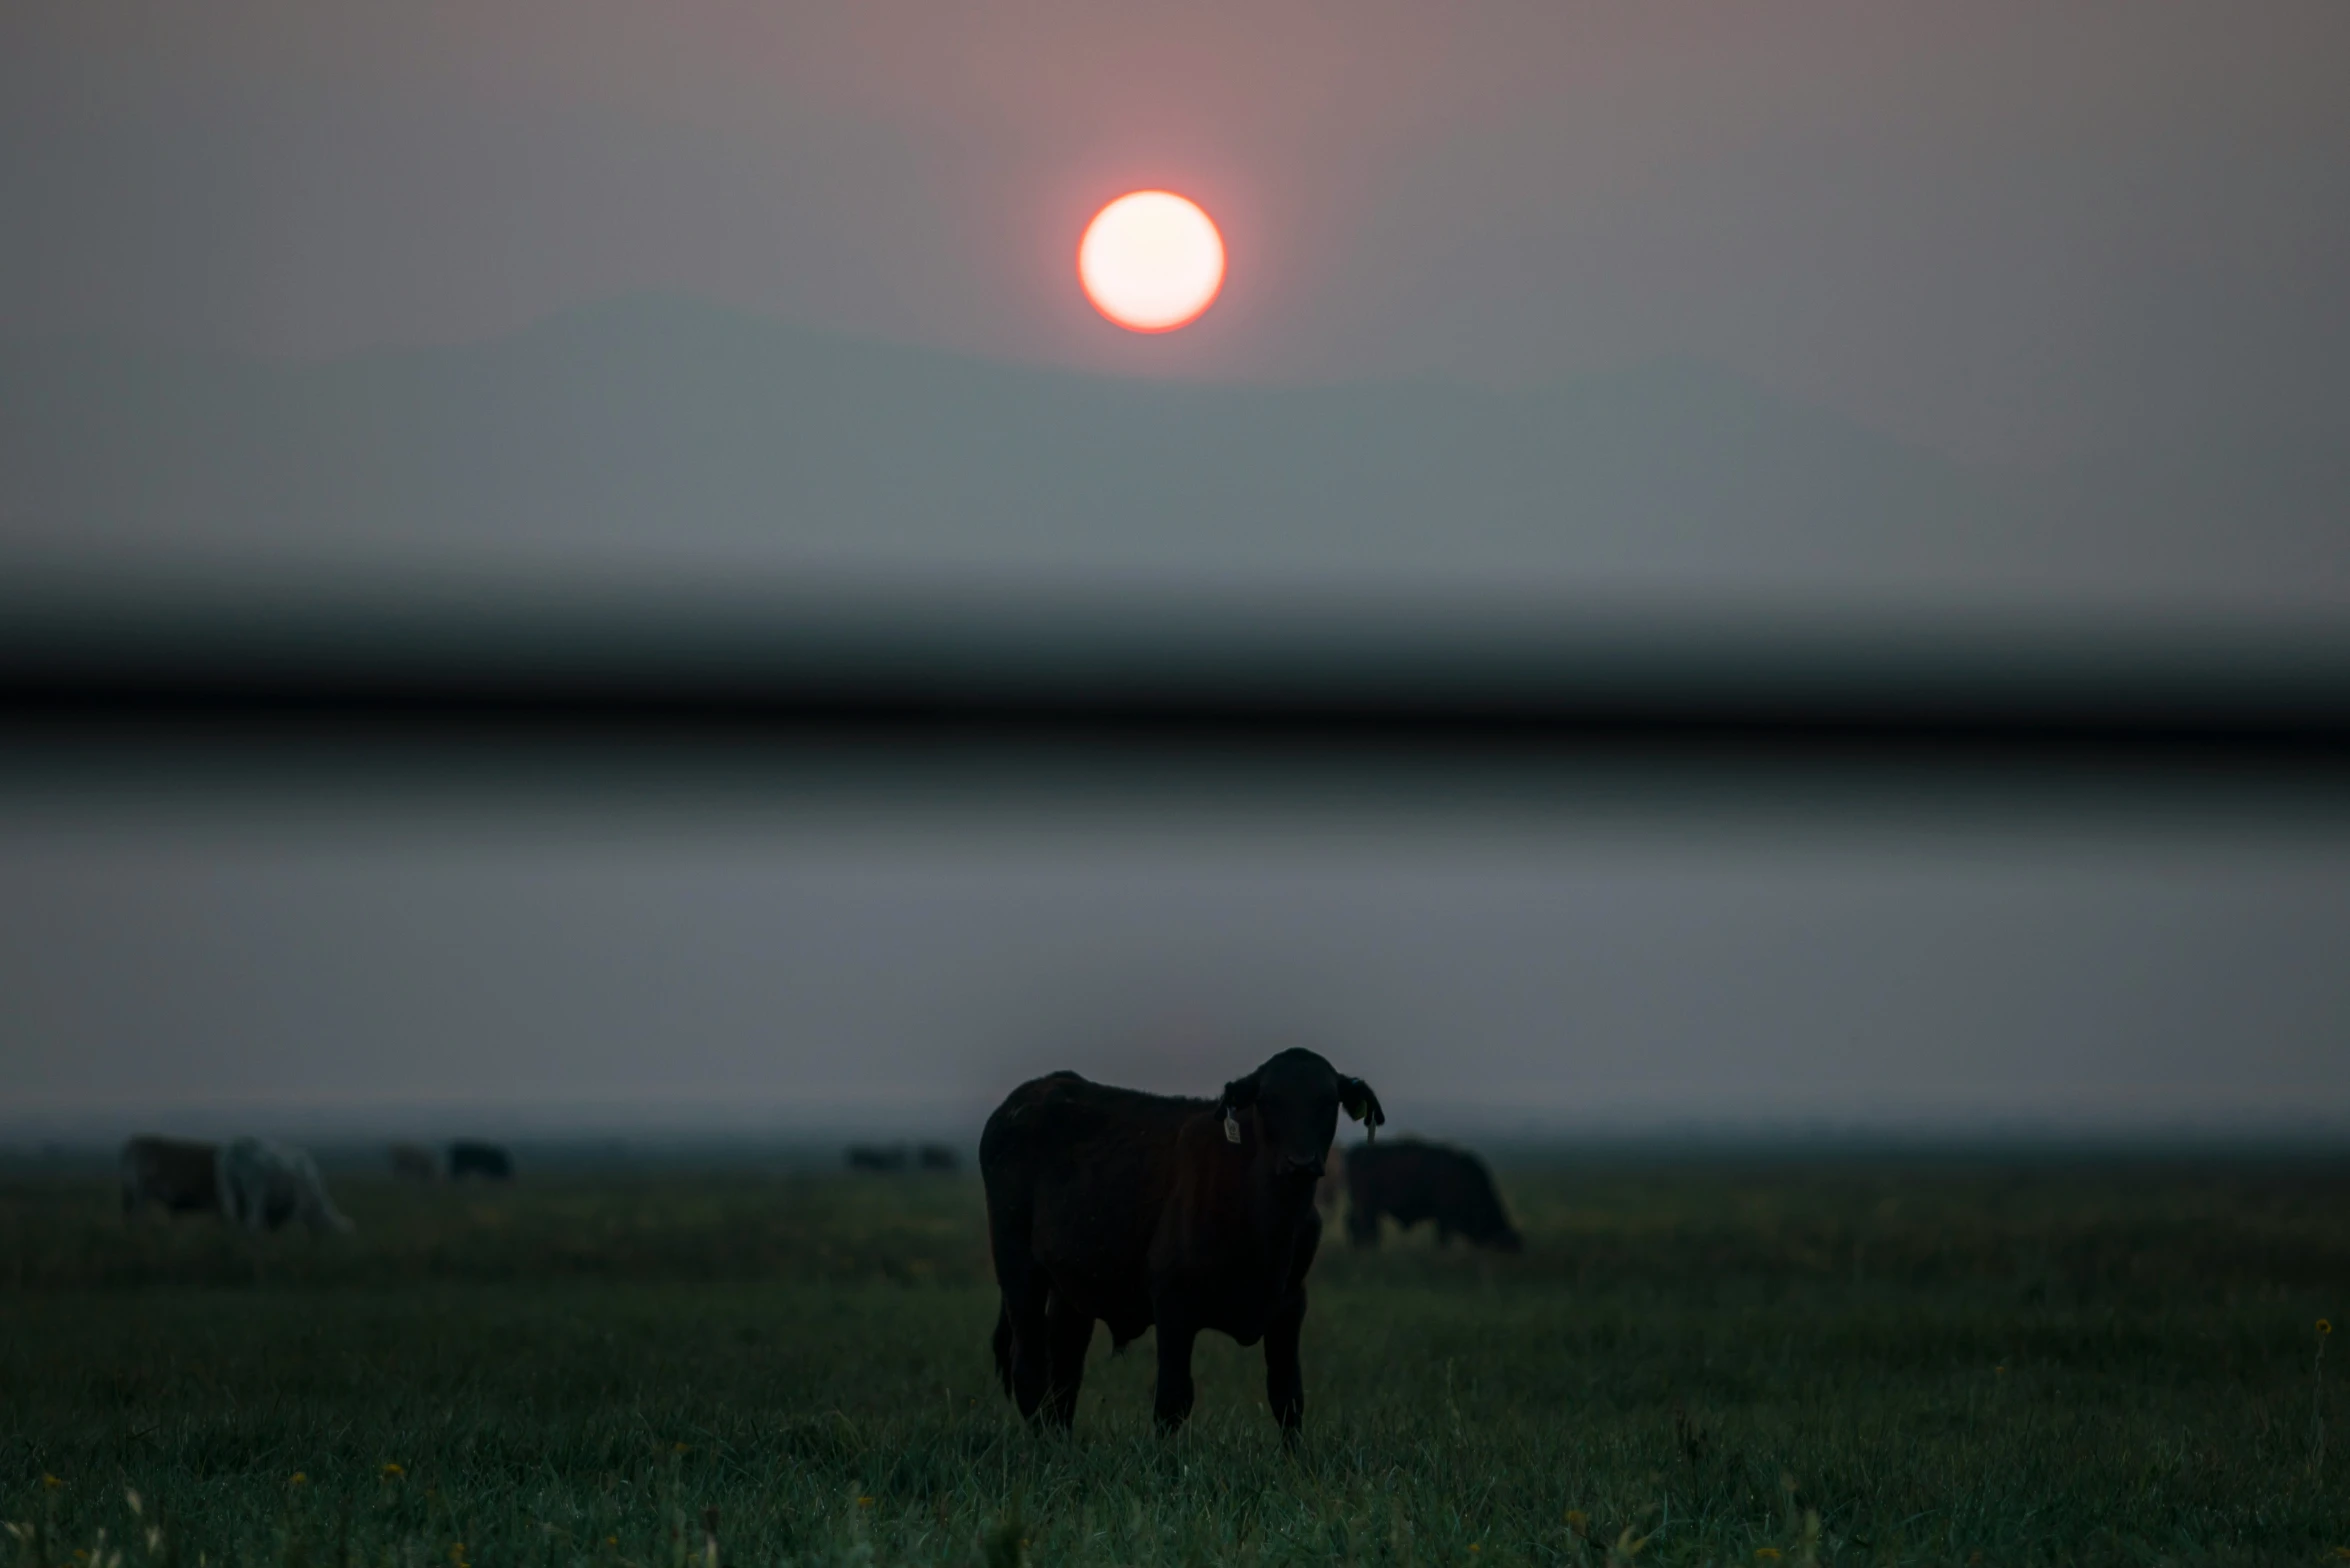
[[980, 1051, 1387, 1436]]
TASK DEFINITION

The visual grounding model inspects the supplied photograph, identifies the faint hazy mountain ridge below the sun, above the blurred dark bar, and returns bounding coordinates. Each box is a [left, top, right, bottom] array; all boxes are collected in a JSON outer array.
[[0, 299, 2350, 592]]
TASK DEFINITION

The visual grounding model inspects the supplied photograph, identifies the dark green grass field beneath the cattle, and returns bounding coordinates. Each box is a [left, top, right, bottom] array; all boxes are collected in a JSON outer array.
[[0, 1159, 2350, 1568]]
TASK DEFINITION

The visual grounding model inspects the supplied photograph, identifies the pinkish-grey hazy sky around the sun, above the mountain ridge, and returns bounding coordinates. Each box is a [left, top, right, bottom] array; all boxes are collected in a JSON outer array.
[[0, 0, 2350, 458]]
